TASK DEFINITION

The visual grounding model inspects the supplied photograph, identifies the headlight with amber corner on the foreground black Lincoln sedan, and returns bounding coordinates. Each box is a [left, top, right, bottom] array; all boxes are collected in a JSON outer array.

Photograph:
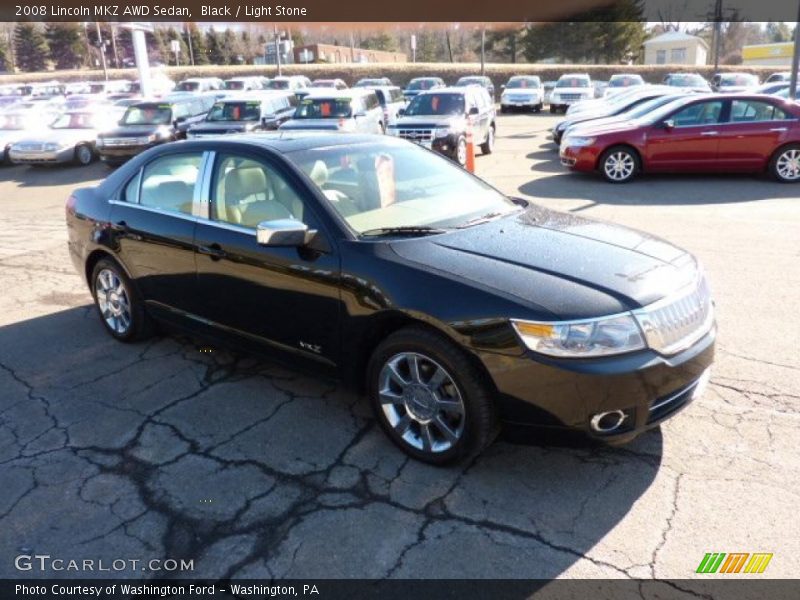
[[511, 314, 646, 358]]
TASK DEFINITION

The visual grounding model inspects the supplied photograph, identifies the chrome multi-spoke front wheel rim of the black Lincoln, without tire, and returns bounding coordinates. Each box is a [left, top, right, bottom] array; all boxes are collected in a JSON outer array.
[[378, 352, 466, 453]]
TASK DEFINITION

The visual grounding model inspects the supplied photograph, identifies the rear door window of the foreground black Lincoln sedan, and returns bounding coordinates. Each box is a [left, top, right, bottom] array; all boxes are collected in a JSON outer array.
[[137, 152, 203, 215]]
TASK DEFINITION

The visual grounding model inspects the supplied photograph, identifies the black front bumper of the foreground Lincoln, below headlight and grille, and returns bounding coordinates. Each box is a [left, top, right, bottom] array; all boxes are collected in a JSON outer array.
[[480, 329, 716, 444]]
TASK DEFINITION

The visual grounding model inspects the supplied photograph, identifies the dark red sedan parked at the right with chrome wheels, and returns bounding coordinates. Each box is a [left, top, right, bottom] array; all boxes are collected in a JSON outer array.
[[560, 94, 800, 183]]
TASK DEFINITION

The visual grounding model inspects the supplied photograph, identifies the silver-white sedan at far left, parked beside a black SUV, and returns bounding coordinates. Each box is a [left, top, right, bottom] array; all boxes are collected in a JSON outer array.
[[9, 111, 112, 165]]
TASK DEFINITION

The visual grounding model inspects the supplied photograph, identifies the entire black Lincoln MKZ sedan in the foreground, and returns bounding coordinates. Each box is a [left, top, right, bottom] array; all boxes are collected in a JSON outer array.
[[67, 132, 715, 463]]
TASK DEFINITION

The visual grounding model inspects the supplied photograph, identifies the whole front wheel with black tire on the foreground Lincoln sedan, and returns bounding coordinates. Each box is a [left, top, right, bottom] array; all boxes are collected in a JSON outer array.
[[367, 327, 498, 465]]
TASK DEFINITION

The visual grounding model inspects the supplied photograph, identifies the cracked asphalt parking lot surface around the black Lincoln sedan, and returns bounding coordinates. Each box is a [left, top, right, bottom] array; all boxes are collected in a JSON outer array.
[[0, 114, 800, 587]]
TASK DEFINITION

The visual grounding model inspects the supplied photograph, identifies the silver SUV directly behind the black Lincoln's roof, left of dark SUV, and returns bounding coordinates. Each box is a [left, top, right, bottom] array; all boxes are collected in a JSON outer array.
[[280, 88, 386, 133]]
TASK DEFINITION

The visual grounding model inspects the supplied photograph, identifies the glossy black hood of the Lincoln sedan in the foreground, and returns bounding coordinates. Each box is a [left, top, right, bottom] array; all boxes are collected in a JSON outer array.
[[392, 206, 698, 319]]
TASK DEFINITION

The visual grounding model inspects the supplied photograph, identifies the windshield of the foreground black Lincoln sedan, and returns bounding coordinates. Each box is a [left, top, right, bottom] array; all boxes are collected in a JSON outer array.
[[287, 141, 519, 233]]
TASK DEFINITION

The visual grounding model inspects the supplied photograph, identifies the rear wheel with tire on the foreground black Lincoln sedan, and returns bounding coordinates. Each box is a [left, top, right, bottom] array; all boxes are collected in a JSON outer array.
[[91, 258, 153, 342]]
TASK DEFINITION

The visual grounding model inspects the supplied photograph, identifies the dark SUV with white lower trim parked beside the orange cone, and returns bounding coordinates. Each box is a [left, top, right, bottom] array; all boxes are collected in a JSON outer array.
[[386, 86, 497, 165]]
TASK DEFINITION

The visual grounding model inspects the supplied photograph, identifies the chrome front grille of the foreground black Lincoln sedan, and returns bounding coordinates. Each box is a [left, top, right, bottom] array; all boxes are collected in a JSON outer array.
[[634, 277, 714, 354]]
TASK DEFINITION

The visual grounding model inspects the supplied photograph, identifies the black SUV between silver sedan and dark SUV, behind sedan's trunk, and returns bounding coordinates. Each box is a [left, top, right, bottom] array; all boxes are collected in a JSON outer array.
[[97, 96, 214, 165]]
